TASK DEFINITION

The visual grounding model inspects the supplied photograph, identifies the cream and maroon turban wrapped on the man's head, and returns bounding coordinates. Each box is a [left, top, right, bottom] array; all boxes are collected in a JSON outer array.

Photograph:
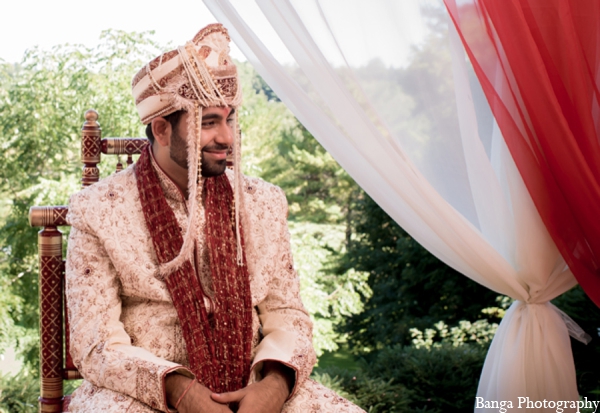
[[132, 24, 242, 125]]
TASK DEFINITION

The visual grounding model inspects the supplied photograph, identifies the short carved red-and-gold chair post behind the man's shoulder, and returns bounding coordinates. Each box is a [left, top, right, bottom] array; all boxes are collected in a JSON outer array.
[[81, 109, 102, 187]]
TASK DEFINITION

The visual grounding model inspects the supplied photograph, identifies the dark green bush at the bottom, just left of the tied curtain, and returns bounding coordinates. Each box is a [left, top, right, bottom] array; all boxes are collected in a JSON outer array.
[[313, 342, 487, 413]]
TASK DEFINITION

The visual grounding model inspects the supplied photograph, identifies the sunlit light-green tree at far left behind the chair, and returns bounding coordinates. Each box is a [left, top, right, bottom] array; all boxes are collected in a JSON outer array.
[[0, 31, 164, 374]]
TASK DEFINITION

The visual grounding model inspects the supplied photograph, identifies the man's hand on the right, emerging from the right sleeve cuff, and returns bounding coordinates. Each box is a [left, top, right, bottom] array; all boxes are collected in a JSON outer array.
[[211, 361, 294, 413]]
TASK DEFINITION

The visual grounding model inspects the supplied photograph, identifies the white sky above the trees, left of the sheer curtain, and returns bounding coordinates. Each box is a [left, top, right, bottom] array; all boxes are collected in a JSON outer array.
[[0, 0, 245, 63]]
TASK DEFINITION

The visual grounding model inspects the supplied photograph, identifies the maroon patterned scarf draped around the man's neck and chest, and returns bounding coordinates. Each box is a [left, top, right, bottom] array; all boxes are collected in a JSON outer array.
[[135, 147, 252, 393]]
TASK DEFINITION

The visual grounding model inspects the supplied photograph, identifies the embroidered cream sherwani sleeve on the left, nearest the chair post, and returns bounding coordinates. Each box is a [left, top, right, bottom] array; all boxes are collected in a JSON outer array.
[[66, 194, 193, 411]]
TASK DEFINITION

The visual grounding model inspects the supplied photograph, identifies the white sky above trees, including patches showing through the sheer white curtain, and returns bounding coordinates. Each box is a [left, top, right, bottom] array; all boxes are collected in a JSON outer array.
[[0, 0, 426, 66]]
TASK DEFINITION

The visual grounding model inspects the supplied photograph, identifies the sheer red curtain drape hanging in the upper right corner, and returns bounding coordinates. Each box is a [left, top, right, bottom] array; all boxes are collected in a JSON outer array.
[[444, 0, 600, 307]]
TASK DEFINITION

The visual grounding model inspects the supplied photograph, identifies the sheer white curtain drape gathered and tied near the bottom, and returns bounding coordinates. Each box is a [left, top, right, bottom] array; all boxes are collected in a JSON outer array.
[[204, 0, 578, 411]]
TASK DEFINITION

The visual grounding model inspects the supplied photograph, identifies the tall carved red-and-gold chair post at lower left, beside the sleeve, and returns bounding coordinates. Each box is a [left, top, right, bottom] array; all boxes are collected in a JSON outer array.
[[29, 207, 67, 412]]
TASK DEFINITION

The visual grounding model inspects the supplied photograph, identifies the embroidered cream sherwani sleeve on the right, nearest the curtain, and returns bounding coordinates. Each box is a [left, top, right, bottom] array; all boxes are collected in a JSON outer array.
[[252, 188, 316, 398]]
